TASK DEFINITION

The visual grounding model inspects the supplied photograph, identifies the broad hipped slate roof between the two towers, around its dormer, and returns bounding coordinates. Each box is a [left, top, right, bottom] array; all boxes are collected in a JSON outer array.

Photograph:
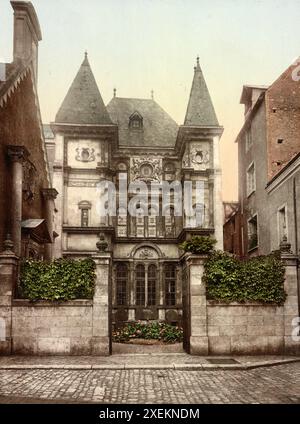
[[107, 97, 178, 147]]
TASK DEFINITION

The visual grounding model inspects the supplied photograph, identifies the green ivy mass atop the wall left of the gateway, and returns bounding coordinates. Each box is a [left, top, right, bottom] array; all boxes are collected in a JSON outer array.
[[18, 258, 96, 301]]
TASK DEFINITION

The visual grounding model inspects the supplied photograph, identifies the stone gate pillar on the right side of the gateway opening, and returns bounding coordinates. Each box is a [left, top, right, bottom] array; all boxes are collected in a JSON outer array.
[[185, 255, 208, 355]]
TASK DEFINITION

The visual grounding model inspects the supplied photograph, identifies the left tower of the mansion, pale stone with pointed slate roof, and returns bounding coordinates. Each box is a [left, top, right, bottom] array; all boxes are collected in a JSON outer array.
[[51, 53, 118, 258]]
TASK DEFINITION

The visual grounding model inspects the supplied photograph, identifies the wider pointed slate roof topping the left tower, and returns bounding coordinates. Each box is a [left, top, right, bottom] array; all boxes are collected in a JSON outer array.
[[55, 54, 112, 125]]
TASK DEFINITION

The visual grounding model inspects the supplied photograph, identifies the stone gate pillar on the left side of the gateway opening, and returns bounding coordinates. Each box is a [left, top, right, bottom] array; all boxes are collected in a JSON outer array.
[[92, 252, 111, 356]]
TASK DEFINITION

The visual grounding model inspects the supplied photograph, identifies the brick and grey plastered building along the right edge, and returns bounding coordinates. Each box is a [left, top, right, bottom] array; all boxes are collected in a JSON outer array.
[[224, 61, 300, 257]]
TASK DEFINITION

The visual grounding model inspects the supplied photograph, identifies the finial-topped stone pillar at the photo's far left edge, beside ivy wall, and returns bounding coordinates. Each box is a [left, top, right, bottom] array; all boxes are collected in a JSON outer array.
[[0, 236, 18, 355]]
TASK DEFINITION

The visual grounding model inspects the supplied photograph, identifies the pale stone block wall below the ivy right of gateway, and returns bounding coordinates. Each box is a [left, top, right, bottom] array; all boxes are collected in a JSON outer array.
[[207, 302, 284, 355]]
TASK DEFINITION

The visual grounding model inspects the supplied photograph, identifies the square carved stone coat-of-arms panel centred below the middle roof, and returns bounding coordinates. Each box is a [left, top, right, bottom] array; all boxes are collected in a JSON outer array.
[[131, 157, 162, 182]]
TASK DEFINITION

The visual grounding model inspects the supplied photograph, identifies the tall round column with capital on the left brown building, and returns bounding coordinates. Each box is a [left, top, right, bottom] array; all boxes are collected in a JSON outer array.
[[7, 146, 29, 256]]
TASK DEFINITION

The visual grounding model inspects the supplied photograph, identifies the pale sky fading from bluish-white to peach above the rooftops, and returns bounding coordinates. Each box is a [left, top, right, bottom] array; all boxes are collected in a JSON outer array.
[[0, 0, 300, 200]]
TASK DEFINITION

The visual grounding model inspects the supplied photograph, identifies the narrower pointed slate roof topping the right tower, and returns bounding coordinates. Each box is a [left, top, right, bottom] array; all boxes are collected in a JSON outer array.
[[184, 58, 219, 126]]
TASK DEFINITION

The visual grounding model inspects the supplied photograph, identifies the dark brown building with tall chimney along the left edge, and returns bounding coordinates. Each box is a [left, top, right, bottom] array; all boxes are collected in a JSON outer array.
[[0, 1, 56, 259]]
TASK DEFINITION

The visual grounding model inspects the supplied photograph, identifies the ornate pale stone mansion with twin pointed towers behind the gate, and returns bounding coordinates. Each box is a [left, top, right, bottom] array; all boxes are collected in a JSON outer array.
[[46, 54, 223, 323]]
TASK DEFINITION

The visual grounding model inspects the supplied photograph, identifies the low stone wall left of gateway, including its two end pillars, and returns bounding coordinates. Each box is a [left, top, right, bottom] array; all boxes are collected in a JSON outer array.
[[0, 250, 111, 356]]
